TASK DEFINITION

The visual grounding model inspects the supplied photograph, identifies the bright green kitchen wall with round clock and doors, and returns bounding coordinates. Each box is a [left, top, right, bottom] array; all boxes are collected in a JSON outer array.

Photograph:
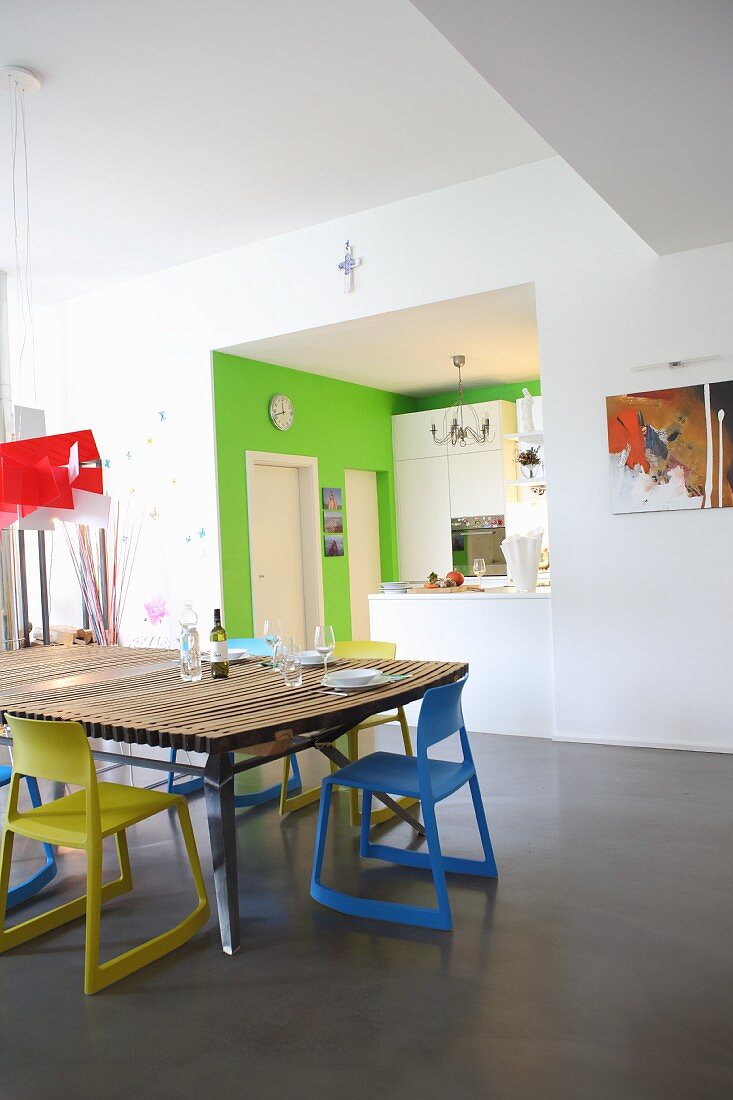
[[214, 352, 416, 638]]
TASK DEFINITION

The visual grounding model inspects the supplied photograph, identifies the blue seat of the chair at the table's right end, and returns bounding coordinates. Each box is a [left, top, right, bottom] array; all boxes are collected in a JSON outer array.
[[326, 752, 474, 800]]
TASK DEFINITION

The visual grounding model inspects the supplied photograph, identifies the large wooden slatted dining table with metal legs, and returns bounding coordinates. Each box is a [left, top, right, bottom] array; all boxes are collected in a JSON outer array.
[[0, 646, 468, 955]]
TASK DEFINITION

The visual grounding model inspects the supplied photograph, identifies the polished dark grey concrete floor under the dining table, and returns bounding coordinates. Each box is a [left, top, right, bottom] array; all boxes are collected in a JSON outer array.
[[0, 734, 733, 1100]]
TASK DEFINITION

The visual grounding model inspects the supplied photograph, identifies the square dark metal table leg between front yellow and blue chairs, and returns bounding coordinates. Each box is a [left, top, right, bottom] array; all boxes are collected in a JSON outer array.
[[204, 752, 240, 955]]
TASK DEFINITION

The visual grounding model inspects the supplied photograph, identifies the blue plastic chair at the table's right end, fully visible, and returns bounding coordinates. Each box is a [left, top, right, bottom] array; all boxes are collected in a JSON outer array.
[[310, 677, 499, 930]]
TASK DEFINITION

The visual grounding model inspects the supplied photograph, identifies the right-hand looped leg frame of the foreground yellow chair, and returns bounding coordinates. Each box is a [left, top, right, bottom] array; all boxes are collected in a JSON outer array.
[[84, 798, 209, 993]]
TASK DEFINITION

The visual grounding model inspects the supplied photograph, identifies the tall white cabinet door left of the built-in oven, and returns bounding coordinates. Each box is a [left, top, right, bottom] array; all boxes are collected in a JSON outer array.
[[395, 455, 452, 581]]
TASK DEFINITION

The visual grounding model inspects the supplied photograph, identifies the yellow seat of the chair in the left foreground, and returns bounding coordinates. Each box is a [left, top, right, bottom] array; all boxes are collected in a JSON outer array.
[[12, 783, 180, 848]]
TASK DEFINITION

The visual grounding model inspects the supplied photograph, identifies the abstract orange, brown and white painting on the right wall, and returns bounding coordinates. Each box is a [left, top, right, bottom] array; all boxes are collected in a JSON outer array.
[[605, 382, 733, 513]]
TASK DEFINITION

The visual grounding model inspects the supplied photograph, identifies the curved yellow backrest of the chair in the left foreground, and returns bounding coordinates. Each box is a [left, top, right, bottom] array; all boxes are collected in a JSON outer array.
[[6, 714, 97, 791]]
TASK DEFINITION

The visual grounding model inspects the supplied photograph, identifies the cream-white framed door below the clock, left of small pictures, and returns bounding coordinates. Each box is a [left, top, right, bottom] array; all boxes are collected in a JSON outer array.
[[249, 463, 306, 646]]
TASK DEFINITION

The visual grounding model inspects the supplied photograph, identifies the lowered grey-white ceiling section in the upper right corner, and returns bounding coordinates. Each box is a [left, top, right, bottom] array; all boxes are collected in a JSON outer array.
[[413, 0, 733, 253]]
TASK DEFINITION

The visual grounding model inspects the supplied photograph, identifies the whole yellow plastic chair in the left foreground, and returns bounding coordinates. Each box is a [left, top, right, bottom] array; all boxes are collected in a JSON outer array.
[[0, 715, 209, 993]]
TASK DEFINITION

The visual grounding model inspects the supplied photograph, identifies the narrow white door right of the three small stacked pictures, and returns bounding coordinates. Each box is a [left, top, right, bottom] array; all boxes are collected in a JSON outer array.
[[344, 470, 382, 641]]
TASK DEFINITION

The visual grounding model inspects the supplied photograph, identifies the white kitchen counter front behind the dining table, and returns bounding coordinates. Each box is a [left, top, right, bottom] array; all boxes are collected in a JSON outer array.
[[369, 587, 555, 737]]
